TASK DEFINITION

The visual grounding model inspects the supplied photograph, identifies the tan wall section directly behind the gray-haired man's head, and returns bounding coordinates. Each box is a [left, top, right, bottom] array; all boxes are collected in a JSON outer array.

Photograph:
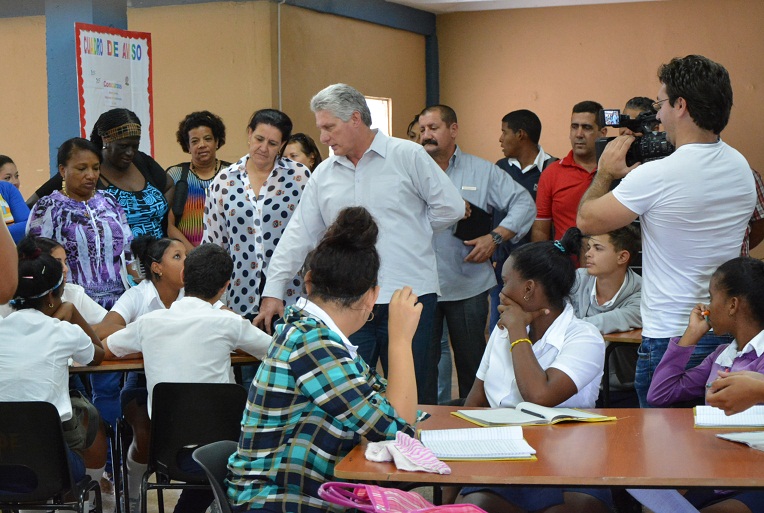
[[281, 6, 426, 157]]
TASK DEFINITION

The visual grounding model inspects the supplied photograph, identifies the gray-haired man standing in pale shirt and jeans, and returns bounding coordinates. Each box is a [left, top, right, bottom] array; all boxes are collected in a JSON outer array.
[[254, 84, 465, 404]]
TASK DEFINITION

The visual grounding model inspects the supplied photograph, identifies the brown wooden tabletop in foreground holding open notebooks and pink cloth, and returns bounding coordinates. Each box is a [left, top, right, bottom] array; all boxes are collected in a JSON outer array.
[[335, 406, 764, 488]]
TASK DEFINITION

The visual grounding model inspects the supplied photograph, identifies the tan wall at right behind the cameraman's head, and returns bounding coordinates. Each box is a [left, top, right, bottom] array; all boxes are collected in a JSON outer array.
[[438, 0, 764, 174]]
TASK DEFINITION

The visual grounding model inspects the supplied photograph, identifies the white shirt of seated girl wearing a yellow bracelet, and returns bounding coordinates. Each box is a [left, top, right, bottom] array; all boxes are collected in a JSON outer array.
[[477, 303, 605, 408]]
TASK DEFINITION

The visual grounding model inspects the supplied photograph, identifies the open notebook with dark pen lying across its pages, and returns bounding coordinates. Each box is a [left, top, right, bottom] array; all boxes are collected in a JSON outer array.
[[451, 402, 616, 427]]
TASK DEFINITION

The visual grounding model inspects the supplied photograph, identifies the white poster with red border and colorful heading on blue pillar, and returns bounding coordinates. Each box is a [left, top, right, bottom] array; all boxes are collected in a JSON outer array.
[[74, 23, 154, 156]]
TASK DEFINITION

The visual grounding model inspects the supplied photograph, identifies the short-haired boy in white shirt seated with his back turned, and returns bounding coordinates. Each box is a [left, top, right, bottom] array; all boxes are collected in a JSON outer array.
[[104, 244, 271, 513]]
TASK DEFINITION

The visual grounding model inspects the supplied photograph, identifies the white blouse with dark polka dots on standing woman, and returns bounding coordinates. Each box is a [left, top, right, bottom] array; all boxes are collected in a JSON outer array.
[[203, 155, 310, 315]]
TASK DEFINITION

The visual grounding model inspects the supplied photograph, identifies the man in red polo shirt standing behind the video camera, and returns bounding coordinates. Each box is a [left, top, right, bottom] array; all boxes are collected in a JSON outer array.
[[531, 101, 607, 242]]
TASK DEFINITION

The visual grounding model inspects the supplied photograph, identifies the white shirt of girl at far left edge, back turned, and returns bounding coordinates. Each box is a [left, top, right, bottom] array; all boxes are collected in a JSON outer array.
[[0, 309, 95, 421]]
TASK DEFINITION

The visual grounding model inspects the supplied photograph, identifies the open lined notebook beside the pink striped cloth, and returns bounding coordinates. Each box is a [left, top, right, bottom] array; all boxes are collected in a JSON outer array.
[[419, 426, 536, 461]]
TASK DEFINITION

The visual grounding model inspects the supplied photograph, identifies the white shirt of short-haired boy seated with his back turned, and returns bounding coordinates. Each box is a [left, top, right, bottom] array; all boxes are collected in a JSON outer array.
[[106, 297, 271, 415]]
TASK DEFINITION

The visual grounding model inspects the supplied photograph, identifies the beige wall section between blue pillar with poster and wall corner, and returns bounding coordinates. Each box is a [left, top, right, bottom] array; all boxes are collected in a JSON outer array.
[[128, 2, 275, 167]]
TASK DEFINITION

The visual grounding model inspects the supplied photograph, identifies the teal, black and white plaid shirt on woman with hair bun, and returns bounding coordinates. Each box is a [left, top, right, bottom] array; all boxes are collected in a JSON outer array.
[[228, 306, 414, 512]]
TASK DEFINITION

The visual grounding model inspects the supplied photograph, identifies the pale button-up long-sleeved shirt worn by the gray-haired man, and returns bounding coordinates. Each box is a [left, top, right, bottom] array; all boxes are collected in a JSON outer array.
[[262, 131, 465, 304]]
